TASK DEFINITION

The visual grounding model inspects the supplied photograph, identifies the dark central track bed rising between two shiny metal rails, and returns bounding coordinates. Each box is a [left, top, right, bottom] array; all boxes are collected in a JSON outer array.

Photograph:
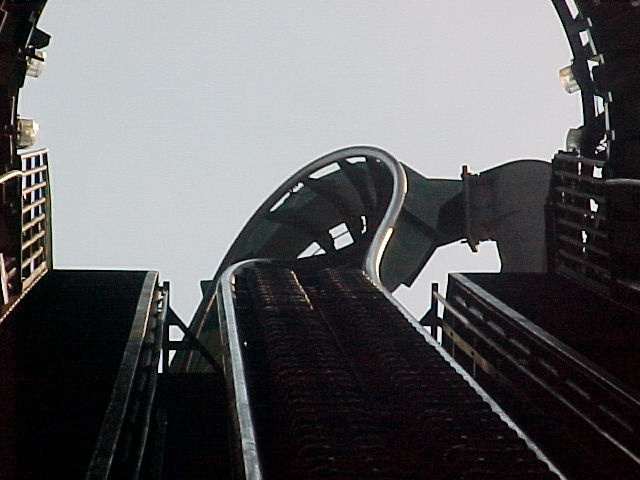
[[223, 263, 558, 480]]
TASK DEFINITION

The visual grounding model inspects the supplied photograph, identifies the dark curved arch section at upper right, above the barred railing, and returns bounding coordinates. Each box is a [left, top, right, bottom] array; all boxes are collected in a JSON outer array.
[[552, 0, 640, 178]]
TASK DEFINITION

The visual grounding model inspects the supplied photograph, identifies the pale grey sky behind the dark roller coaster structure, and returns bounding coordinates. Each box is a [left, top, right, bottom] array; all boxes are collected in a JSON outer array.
[[20, 0, 581, 319]]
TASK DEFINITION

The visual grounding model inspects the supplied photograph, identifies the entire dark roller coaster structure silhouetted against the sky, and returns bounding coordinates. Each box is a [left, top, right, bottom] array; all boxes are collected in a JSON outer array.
[[0, 0, 640, 479]]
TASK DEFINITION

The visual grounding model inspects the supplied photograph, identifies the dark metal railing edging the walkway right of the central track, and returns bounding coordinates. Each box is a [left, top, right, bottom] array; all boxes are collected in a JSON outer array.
[[432, 274, 640, 472]]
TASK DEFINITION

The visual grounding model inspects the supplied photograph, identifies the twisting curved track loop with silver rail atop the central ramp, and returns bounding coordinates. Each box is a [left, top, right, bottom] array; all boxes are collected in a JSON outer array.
[[182, 146, 407, 369]]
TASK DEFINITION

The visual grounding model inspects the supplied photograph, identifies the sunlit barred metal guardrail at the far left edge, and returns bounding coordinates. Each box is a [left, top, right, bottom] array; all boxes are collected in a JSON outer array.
[[0, 149, 53, 316]]
